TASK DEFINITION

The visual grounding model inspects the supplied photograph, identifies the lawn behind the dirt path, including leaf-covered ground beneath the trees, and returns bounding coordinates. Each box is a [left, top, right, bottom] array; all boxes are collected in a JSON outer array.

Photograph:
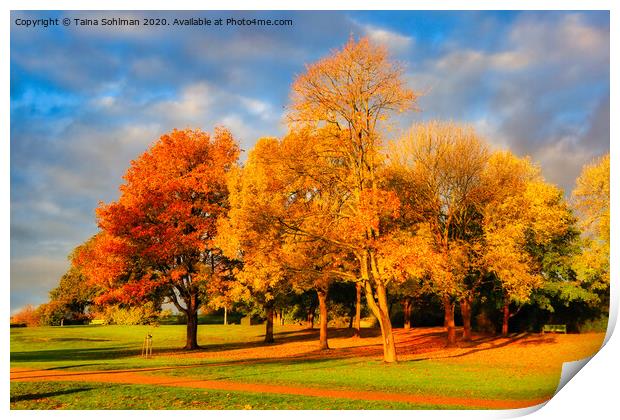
[[11, 325, 603, 408]]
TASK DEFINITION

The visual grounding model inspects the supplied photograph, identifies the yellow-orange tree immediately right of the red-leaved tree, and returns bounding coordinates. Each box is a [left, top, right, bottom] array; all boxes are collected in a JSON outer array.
[[216, 138, 290, 343]]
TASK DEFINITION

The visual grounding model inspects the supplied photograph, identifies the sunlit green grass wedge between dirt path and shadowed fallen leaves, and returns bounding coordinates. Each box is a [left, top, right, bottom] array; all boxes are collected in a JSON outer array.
[[152, 358, 560, 399]]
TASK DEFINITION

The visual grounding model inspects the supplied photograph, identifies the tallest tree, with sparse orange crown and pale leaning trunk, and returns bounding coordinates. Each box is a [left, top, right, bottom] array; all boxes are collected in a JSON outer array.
[[289, 38, 416, 362]]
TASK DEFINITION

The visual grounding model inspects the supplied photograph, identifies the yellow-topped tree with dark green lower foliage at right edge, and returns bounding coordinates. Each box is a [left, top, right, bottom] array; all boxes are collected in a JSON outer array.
[[516, 155, 609, 328]]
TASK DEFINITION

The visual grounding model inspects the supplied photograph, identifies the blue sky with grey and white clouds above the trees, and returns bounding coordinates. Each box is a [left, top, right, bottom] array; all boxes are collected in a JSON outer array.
[[11, 11, 609, 311]]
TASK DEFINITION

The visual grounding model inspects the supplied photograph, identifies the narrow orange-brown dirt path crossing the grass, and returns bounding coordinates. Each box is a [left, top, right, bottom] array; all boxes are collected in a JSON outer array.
[[11, 369, 547, 409]]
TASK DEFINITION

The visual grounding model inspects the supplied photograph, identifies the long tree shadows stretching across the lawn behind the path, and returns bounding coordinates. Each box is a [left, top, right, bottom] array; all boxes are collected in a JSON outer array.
[[11, 328, 546, 372]]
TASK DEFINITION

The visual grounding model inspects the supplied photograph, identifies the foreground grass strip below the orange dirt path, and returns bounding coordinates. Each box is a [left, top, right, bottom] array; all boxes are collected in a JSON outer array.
[[11, 382, 456, 410]]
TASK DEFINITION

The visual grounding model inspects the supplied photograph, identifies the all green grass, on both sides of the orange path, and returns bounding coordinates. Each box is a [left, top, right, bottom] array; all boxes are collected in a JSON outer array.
[[11, 325, 592, 408]]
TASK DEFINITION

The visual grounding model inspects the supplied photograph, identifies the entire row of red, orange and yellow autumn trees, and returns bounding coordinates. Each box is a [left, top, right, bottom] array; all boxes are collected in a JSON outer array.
[[43, 38, 610, 362]]
